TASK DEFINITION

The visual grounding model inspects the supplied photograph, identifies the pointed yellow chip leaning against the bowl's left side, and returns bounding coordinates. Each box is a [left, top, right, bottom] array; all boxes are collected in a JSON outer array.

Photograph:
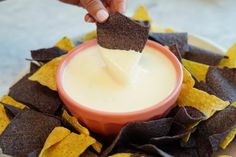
[[29, 55, 65, 91]]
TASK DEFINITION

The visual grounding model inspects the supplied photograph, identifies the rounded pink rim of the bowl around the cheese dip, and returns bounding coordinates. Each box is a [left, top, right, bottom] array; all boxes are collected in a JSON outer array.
[[56, 39, 183, 118]]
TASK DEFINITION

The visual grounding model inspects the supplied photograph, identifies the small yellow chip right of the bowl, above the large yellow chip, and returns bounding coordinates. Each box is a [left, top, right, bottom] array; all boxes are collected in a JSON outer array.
[[182, 59, 209, 82]]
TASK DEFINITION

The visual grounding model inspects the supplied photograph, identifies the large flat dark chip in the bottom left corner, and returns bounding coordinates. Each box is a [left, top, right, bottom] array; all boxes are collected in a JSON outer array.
[[0, 109, 61, 156]]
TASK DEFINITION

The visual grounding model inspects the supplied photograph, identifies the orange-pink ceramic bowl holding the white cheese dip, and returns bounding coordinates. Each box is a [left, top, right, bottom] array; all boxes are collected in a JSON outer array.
[[57, 40, 183, 136]]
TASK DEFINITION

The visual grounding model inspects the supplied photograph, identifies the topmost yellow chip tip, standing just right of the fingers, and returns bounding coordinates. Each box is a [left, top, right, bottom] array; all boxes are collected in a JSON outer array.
[[132, 5, 151, 22]]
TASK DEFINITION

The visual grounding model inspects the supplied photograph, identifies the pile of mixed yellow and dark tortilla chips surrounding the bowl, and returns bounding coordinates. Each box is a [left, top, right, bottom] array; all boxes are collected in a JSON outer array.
[[0, 6, 236, 157]]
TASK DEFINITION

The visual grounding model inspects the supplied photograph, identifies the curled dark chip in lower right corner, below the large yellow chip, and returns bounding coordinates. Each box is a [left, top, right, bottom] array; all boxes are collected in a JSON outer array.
[[196, 106, 236, 157]]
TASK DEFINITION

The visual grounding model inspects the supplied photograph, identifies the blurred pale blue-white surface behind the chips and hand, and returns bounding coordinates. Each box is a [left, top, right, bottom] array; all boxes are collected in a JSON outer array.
[[0, 0, 236, 96]]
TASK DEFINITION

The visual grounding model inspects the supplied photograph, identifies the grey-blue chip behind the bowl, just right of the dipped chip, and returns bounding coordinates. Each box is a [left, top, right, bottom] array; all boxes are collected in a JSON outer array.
[[149, 33, 189, 57]]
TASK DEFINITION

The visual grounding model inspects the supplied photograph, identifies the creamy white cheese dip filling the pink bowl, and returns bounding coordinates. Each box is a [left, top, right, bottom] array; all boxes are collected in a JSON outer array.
[[62, 45, 177, 113]]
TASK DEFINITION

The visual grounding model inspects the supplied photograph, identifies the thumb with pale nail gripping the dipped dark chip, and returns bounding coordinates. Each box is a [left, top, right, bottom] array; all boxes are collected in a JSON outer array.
[[80, 0, 109, 22]]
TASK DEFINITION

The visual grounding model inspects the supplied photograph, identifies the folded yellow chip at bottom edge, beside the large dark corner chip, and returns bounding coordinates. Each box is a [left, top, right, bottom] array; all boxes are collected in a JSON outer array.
[[39, 127, 96, 157]]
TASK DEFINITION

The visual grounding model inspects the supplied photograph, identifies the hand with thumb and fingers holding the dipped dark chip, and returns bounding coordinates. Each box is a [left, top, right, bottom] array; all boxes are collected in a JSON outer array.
[[60, 0, 126, 22]]
